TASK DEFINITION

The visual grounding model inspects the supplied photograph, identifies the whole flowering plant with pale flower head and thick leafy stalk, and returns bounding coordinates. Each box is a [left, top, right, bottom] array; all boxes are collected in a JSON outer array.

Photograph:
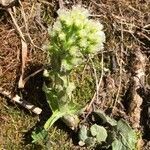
[[32, 6, 105, 141]]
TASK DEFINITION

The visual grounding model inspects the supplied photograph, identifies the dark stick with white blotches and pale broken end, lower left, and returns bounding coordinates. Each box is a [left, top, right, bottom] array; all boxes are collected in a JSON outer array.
[[0, 87, 42, 115]]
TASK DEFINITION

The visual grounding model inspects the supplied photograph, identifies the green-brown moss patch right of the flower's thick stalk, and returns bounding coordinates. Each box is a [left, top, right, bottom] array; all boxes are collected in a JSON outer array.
[[71, 56, 101, 107]]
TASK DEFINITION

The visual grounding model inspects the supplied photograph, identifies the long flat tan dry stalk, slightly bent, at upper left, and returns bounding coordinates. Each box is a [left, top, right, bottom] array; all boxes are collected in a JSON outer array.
[[7, 8, 27, 88]]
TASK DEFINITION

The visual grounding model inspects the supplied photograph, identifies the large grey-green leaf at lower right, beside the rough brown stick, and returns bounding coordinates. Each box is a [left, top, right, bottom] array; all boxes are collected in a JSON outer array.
[[117, 119, 138, 150]]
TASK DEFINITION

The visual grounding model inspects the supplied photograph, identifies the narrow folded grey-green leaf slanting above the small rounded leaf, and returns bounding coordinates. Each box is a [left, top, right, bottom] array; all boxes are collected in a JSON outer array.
[[94, 110, 117, 126]]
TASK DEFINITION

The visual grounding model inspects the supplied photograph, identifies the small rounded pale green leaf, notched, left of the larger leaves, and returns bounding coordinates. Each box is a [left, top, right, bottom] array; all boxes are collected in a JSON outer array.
[[90, 124, 107, 143]]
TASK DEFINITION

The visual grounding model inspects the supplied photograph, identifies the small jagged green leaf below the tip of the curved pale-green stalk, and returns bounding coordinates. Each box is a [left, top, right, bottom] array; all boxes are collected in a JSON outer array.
[[31, 129, 48, 143]]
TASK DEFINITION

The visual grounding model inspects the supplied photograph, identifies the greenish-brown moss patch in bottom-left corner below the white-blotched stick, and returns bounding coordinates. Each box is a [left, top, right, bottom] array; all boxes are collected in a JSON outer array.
[[0, 99, 37, 150]]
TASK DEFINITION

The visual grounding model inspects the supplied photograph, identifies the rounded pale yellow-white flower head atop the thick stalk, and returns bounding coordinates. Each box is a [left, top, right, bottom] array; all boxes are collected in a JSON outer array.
[[49, 6, 105, 71]]
